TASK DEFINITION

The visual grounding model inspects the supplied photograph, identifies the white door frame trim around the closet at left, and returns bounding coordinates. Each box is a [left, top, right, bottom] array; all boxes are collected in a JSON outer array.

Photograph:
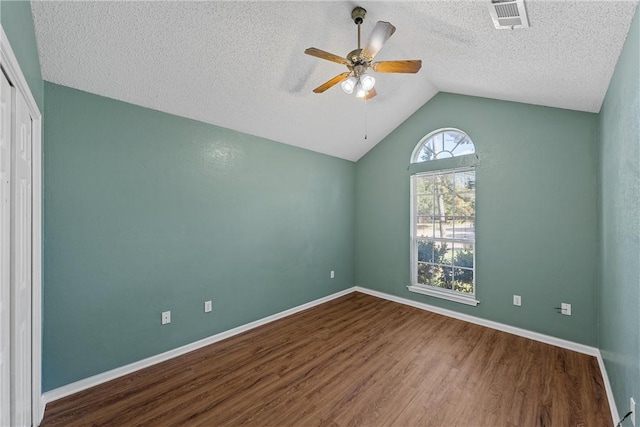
[[0, 24, 44, 426]]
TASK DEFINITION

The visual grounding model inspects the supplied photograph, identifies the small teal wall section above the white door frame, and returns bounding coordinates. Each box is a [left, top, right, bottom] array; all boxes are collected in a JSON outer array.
[[0, 0, 44, 112]]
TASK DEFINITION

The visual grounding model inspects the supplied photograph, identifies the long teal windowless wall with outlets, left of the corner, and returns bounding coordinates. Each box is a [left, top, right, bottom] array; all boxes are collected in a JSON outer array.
[[43, 82, 355, 391]]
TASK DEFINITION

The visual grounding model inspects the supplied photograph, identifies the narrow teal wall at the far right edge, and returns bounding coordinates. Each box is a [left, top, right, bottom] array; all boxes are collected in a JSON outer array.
[[598, 4, 640, 426]]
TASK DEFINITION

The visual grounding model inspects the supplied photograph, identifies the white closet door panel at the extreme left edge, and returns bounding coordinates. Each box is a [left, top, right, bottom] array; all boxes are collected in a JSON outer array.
[[0, 72, 13, 426]]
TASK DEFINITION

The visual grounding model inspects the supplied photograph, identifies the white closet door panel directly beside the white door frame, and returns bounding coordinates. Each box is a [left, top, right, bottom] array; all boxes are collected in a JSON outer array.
[[11, 78, 33, 426]]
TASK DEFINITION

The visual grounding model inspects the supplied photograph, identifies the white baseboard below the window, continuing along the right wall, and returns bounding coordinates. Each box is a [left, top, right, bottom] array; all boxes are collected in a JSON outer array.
[[355, 286, 620, 425]]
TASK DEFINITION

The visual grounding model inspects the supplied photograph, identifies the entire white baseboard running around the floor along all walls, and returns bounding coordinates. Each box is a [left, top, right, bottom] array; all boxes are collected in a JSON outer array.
[[42, 286, 620, 425]]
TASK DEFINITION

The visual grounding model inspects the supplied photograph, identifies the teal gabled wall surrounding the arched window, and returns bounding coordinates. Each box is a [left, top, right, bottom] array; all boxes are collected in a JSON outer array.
[[356, 93, 598, 345]]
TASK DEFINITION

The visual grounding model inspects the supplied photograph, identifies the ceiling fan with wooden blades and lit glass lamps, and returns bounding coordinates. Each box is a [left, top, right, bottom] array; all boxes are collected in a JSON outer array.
[[304, 7, 422, 99]]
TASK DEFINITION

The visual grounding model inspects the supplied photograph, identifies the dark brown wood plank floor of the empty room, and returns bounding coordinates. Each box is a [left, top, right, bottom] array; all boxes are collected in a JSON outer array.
[[42, 293, 612, 426]]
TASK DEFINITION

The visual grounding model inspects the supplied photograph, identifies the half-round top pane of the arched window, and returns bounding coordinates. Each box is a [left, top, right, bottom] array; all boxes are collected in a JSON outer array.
[[411, 129, 476, 163]]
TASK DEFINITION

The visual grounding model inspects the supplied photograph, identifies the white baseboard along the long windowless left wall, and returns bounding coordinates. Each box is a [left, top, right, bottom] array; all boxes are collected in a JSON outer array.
[[42, 287, 355, 405]]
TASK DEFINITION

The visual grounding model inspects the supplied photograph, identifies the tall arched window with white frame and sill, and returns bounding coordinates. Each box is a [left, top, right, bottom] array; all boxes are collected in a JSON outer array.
[[409, 129, 478, 305]]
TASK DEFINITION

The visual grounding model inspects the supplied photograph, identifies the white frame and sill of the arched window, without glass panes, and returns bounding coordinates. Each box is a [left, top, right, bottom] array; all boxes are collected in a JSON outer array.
[[407, 128, 480, 306]]
